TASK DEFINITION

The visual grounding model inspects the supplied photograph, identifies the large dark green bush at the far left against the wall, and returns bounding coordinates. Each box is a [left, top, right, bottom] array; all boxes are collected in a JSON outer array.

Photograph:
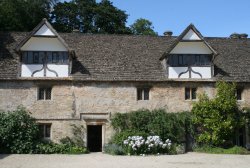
[[0, 107, 38, 153]]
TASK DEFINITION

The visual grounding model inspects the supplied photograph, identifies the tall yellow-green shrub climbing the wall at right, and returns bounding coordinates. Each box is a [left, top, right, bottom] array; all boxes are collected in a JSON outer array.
[[192, 82, 243, 147]]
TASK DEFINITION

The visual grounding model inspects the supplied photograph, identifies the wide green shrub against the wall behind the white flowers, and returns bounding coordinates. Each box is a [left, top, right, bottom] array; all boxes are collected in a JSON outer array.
[[111, 109, 193, 143]]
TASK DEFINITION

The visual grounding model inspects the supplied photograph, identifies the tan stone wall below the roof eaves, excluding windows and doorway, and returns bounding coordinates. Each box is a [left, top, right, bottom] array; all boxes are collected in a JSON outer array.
[[0, 81, 250, 143]]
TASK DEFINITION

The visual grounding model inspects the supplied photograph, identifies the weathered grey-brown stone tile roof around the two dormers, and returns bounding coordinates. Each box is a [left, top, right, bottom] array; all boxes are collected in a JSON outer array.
[[0, 32, 250, 82]]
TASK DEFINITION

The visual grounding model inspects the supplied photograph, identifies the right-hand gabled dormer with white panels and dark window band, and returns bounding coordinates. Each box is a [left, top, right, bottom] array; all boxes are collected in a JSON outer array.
[[161, 24, 217, 79]]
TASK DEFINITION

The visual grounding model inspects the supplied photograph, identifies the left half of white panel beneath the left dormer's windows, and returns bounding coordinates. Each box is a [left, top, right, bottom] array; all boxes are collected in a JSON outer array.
[[21, 64, 44, 77]]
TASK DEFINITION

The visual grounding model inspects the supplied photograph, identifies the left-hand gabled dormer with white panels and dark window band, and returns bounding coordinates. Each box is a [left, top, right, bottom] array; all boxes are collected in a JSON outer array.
[[16, 19, 73, 77]]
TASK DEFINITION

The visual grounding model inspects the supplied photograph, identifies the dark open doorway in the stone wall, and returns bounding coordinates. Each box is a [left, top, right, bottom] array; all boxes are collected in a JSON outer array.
[[87, 125, 102, 152]]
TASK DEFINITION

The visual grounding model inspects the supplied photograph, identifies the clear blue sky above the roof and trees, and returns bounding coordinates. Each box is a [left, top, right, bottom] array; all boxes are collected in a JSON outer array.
[[62, 0, 250, 37]]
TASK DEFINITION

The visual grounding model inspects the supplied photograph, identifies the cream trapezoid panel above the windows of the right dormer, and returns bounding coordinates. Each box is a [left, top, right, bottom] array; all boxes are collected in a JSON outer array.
[[170, 42, 212, 54]]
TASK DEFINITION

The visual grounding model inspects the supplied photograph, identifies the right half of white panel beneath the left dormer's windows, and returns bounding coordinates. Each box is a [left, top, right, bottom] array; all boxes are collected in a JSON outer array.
[[46, 64, 69, 77]]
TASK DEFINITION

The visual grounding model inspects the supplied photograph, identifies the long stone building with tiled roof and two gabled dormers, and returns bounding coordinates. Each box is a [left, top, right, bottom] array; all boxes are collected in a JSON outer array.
[[0, 19, 250, 151]]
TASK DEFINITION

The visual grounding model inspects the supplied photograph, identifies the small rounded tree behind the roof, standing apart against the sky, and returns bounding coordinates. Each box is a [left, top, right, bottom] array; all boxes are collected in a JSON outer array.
[[130, 18, 157, 36]]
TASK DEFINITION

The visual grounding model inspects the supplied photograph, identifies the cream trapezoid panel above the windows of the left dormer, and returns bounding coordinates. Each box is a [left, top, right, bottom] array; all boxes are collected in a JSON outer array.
[[21, 37, 67, 51]]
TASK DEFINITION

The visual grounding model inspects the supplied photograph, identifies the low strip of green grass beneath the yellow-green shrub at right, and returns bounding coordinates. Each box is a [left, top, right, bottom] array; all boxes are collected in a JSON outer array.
[[194, 146, 250, 155]]
